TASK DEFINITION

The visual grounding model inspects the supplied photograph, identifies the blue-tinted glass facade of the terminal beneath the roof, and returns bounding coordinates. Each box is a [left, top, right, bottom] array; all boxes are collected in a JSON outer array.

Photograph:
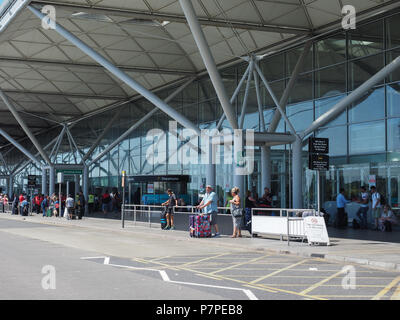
[[8, 10, 400, 207]]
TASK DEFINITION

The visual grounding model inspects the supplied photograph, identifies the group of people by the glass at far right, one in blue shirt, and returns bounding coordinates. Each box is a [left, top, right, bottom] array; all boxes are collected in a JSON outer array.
[[335, 186, 397, 231]]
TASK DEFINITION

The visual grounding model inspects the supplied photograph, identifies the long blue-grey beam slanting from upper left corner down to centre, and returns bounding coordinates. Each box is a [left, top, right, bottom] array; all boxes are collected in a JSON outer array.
[[28, 5, 201, 136]]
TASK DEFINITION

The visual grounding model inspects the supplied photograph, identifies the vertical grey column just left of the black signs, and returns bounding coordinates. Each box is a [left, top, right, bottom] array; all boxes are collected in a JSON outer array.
[[292, 137, 303, 209]]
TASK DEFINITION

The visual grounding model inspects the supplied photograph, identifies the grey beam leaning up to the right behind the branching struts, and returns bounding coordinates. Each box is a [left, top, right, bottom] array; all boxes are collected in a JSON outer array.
[[268, 41, 312, 132]]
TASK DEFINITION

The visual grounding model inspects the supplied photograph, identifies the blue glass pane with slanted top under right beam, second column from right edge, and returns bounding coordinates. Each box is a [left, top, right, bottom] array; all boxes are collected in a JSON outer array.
[[349, 87, 385, 122]]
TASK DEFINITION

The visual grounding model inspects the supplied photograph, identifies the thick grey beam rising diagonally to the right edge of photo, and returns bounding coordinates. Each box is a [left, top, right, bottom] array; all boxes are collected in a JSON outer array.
[[300, 57, 400, 139]]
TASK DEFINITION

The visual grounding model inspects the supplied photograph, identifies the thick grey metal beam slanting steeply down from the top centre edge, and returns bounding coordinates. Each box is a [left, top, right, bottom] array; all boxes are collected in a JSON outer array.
[[179, 0, 238, 129]]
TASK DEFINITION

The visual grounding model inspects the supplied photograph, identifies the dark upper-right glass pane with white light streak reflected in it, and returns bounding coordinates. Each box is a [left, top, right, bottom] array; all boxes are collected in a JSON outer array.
[[348, 20, 384, 59]]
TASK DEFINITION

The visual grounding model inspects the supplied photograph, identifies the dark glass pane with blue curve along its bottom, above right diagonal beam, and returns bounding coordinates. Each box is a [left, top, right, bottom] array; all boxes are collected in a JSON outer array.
[[315, 63, 346, 98]]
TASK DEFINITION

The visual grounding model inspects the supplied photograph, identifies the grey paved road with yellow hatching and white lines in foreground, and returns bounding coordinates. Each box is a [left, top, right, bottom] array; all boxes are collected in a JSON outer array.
[[0, 219, 400, 300]]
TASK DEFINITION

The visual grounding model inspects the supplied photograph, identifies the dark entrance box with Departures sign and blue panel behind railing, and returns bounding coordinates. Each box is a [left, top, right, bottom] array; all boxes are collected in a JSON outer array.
[[127, 175, 191, 205]]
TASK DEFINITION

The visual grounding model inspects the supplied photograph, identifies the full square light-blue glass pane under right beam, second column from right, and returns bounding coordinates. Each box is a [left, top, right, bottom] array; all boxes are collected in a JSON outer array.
[[349, 121, 386, 154]]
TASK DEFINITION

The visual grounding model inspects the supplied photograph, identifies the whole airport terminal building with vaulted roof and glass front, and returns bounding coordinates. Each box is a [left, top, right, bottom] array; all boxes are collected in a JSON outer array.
[[0, 0, 400, 212]]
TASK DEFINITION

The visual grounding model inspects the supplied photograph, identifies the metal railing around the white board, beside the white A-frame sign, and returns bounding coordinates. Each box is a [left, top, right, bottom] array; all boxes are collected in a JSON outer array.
[[251, 208, 317, 245]]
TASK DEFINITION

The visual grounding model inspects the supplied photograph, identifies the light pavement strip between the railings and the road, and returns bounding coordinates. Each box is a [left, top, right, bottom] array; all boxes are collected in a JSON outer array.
[[0, 214, 400, 271]]
